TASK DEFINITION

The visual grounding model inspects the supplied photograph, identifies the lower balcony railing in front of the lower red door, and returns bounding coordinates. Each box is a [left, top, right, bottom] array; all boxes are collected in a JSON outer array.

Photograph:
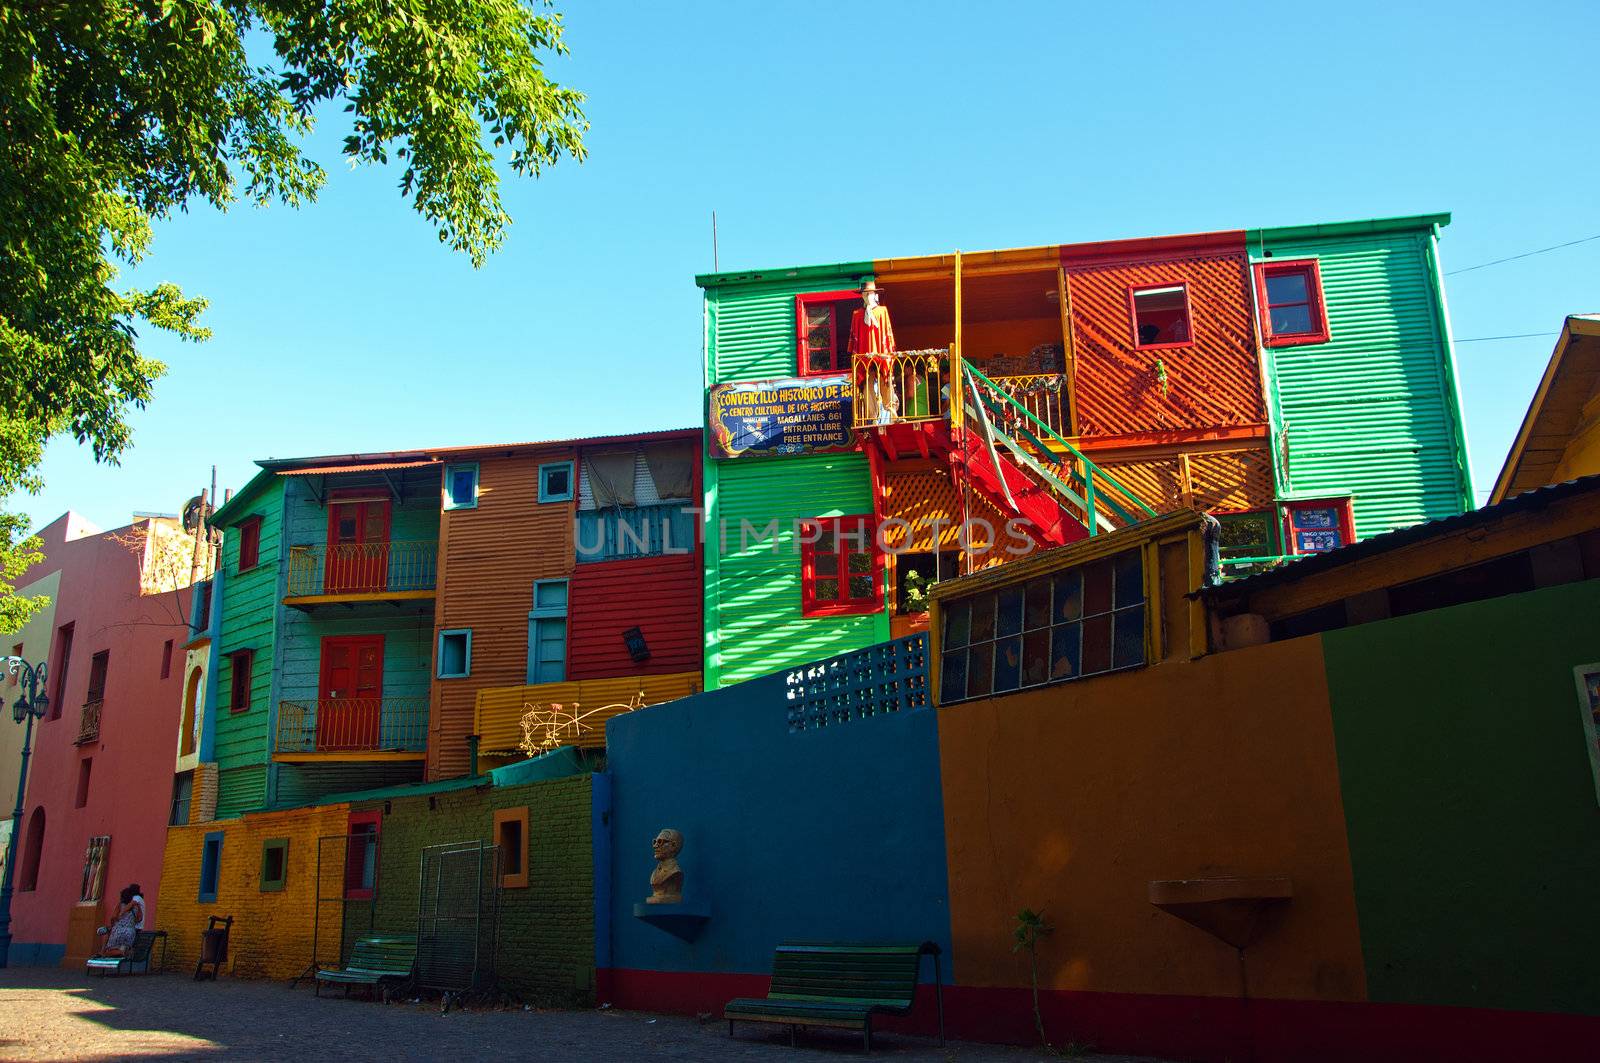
[[272, 696, 427, 760]]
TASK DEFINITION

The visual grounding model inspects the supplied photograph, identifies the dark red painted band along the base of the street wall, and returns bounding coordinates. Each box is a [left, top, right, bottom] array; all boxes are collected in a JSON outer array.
[[597, 964, 1600, 1063]]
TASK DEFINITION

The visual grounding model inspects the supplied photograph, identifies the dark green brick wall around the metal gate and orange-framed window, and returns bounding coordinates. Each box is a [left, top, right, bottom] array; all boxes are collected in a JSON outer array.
[[350, 775, 595, 1005]]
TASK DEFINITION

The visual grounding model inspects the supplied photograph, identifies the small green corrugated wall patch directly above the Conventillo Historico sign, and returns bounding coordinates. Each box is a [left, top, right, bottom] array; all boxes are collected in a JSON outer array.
[[706, 263, 872, 384]]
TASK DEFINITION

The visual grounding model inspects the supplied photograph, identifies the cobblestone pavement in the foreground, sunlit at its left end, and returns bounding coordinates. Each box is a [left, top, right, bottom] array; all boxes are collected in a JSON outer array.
[[0, 967, 1177, 1063]]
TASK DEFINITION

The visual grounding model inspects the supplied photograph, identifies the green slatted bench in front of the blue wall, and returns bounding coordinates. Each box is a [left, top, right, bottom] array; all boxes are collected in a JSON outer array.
[[723, 941, 944, 1052]]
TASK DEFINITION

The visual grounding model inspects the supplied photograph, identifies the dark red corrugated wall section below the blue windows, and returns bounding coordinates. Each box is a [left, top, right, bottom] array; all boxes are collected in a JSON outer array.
[[566, 552, 704, 679]]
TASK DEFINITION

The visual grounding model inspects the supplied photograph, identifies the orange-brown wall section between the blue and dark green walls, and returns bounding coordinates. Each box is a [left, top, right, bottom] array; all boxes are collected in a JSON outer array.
[[939, 639, 1366, 1001]]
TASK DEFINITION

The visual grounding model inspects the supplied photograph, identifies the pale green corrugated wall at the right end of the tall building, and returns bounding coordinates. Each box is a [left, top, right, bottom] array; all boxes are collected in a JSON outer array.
[[1250, 229, 1472, 538]]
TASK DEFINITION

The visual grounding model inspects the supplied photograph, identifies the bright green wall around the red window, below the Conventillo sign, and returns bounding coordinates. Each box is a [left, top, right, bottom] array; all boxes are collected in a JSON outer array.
[[706, 453, 890, 690]]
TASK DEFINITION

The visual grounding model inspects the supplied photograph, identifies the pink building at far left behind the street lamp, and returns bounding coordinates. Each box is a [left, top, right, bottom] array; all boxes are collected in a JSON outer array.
[[11, 512, 210, 965]]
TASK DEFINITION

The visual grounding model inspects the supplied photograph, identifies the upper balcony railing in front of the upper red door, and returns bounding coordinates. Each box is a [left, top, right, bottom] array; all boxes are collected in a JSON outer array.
[[283, 540, 438, 608]]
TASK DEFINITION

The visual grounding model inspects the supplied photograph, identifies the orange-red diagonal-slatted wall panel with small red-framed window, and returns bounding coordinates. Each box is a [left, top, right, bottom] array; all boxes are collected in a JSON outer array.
[[1066, 248, 1267, 439]]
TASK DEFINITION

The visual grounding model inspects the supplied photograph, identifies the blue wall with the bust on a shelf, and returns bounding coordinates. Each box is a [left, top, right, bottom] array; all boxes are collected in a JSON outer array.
[[606, 674, 950, 981]]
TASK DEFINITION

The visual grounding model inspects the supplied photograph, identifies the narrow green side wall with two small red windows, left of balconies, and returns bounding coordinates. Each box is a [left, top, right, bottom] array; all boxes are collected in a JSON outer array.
[[216, 477, 285, 815]]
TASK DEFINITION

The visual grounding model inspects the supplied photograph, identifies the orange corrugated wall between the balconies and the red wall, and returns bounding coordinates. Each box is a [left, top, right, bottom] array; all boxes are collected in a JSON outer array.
[[427, 448, 578, 778]]
